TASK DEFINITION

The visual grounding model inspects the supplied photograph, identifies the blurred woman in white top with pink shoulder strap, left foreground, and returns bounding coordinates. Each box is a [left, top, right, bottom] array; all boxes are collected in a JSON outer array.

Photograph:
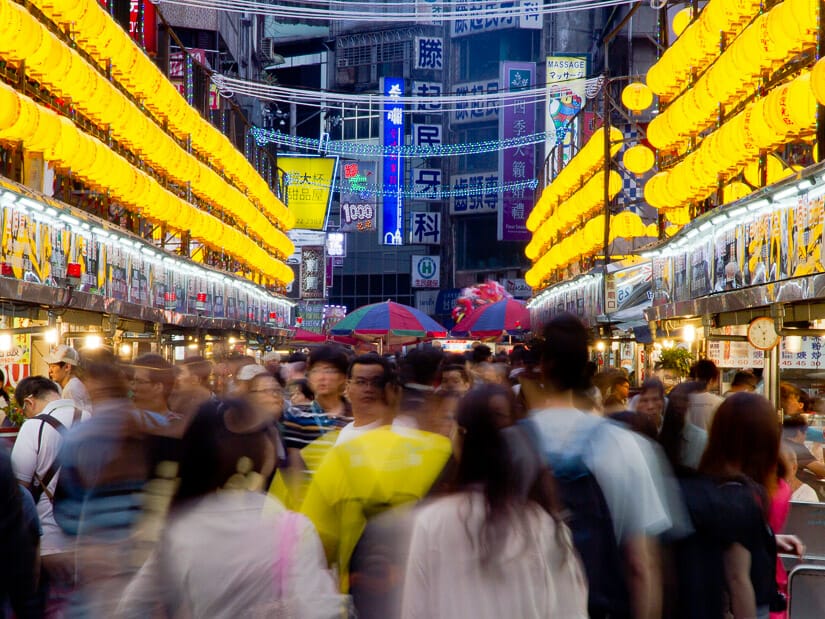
[[117, 400, 347, 619]]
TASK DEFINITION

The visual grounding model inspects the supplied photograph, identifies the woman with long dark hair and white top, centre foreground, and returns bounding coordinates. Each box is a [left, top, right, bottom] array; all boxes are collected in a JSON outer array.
[[401, 385, 588, 619]]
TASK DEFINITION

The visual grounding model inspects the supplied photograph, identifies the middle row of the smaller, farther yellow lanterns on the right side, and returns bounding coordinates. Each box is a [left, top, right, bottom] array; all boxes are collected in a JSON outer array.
[[524, 170, 622, 260]]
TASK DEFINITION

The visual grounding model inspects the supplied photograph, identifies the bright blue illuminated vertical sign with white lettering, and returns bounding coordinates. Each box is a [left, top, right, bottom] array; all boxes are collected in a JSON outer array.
[[381, 77, 404, 245]]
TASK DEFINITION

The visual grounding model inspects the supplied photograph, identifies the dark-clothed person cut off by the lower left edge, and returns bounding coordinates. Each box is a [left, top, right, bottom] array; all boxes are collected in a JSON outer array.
[[0, 447, 43, 619]]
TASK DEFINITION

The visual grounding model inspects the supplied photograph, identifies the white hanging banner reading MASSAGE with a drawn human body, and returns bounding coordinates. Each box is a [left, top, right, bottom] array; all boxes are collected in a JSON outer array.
[[544, 54, 587, 170]]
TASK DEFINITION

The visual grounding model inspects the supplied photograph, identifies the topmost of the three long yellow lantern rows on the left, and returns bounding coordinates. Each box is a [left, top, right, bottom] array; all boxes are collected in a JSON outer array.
[[25, 0, 295, 229]]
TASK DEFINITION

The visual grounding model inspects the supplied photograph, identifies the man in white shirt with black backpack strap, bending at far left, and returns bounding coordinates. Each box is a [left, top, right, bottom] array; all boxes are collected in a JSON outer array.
[[11, 376, 89, 612]]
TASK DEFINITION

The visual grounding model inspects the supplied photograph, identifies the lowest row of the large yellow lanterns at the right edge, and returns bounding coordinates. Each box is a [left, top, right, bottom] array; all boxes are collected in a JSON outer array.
[[644, 70, 825, 208]]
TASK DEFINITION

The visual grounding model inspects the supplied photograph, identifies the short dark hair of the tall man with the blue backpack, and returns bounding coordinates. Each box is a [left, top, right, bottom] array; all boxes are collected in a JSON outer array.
[[541, 313, 590, 392]]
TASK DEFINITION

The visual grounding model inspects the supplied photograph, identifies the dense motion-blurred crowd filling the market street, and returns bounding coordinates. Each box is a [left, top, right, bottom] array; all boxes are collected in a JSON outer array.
[[0, 315, 825, 619]]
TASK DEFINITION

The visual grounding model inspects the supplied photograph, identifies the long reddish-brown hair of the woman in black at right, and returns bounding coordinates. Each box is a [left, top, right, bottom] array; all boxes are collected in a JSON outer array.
[[699, 392, 780, 493]]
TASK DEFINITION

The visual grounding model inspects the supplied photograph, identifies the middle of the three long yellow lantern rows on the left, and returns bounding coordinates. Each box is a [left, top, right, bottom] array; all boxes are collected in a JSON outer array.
[[0, 0, 293, 258]]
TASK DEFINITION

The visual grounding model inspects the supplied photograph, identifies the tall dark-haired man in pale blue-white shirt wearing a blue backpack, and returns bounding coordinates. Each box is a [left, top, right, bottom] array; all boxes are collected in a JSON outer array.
[[505, 314, 673, 619]]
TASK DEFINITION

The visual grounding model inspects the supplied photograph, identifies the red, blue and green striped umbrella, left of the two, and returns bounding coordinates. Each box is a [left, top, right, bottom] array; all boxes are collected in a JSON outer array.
[[330, 301, 447, 344]]
